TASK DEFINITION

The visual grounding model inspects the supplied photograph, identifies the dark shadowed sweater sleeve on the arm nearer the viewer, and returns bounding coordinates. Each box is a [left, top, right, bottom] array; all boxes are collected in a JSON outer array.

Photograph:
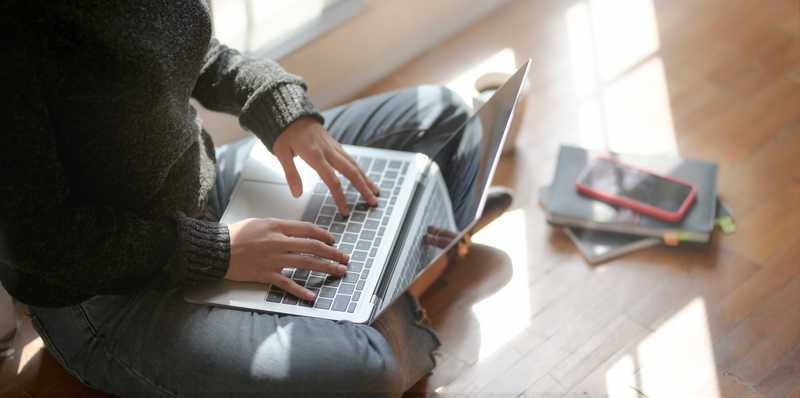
[[0, 43, 229, 306]]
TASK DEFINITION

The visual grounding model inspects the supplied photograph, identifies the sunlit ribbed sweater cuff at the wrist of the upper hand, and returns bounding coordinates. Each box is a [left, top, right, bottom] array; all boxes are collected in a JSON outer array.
[[239, 83, 325, 151]]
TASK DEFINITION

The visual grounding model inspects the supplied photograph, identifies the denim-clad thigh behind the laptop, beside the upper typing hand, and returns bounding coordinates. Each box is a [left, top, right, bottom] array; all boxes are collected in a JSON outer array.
[[323, 86, 470, 158]]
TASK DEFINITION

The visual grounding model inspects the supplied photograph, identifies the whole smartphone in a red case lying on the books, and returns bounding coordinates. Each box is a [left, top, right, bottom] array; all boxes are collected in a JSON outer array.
[[575, 157, 697, 222]]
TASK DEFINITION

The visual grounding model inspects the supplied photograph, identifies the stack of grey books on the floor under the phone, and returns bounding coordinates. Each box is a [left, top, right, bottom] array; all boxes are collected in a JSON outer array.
[[539, 145, 735, 264]]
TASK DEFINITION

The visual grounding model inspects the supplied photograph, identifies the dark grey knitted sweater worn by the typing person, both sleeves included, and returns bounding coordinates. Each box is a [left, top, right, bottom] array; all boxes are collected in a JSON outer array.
[[0, 0, 321, 306]]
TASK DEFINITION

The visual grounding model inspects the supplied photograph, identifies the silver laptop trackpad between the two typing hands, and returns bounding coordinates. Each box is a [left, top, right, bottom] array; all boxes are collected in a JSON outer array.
[[222, 180, 311, 224]]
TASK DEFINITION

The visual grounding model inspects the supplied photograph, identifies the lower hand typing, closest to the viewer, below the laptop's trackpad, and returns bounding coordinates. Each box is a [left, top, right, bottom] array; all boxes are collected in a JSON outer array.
[[225, 218, 349, 300]]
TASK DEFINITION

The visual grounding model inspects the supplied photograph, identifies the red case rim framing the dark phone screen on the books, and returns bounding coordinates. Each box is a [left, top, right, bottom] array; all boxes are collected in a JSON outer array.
[[575, 156, 697, 222]]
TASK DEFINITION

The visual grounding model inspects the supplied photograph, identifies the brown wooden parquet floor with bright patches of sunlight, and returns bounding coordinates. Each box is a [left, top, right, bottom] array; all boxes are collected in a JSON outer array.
[[0, 0, 800, 398]]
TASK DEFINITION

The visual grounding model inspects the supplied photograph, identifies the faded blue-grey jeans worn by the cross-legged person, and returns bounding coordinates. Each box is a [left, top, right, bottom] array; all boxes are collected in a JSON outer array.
[[30, 86, 468, 397]]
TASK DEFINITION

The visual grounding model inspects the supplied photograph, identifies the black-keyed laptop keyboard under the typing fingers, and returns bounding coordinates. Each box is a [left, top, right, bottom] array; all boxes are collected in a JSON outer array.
[[266, 156, 409, 313]]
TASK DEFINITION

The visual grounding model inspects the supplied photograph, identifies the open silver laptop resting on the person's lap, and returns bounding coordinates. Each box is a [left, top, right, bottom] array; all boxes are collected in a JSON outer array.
[[184, 60, 530, 323]]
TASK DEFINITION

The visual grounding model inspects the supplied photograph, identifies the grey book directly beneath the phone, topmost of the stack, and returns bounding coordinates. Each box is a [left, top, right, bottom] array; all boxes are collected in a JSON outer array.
[[548, 145, 717, 245]]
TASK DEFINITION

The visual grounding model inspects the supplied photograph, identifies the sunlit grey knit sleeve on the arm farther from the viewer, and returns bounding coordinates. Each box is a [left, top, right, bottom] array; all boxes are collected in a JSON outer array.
[[192, 39, 323, 150]]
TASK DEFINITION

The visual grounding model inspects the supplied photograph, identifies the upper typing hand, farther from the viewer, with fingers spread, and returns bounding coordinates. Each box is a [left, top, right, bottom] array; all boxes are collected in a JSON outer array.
[[272, 117, 380, 216]]
